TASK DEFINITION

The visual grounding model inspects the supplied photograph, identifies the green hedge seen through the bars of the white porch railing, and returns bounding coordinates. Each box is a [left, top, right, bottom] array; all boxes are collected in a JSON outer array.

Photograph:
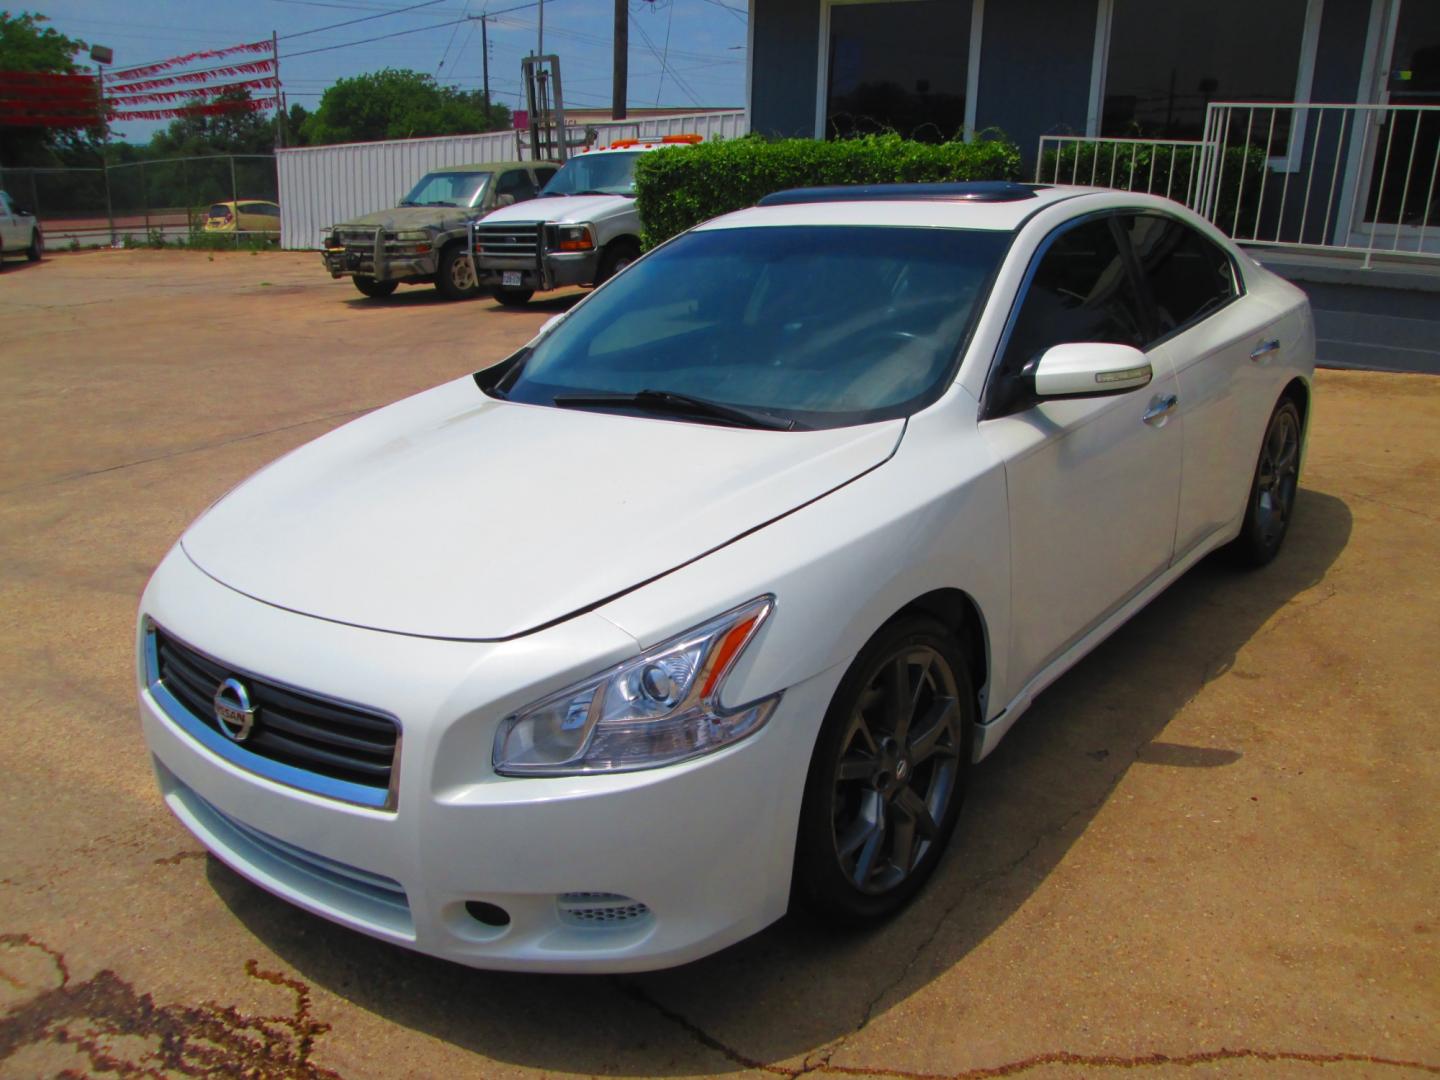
[[1037, 143, 1279, 236]]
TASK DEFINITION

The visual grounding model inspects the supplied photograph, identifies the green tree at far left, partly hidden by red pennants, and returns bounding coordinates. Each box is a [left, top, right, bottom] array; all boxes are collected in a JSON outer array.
[[0, 12, 105, 166]]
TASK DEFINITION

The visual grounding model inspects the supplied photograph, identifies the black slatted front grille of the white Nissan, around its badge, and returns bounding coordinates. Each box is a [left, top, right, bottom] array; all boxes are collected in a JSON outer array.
[[154, 626, 399, 792]]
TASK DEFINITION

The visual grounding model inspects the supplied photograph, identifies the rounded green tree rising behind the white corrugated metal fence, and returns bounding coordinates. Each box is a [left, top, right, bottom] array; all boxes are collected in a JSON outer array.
[[301, 68, 510, 145]]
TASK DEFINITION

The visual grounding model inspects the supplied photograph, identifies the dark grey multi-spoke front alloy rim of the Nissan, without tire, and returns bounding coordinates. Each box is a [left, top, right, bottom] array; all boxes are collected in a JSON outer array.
[[832, 645, 963, 894]]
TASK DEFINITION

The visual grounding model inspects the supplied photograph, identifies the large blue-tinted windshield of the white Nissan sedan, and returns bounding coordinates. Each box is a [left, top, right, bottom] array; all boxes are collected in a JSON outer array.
[[482, 226, 1009, 428]]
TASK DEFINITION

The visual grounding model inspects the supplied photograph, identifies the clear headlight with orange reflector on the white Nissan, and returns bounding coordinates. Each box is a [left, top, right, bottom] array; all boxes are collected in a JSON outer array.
[[494, 596, 779, 776]]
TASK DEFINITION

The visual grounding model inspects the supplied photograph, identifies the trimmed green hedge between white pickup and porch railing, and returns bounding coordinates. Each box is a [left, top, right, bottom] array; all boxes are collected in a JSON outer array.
[[635, 135, 1020, 248]]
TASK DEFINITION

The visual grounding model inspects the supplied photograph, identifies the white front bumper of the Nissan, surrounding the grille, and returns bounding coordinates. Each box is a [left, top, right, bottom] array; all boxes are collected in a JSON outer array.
[[140, 549, 838, 972]]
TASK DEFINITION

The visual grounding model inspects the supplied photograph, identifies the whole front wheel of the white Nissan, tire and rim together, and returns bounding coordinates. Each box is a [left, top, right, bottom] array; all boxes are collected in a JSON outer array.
[[792, 616, 976, 926]]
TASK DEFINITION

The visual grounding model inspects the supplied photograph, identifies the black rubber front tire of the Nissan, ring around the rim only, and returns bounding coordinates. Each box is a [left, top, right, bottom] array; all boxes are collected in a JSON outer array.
[[791, 616, 978, 926]]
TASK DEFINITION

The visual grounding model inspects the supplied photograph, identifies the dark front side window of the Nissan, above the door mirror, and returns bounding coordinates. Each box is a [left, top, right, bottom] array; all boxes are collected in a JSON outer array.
[[999, 217, 1148, 376]]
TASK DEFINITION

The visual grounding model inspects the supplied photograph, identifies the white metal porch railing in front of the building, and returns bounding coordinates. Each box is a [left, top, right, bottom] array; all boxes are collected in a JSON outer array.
[[1035, 102, 1440, 266]]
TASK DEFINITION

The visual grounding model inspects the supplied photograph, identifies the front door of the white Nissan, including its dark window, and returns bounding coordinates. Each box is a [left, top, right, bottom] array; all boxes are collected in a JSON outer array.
[[982, 216, 1184, 693]]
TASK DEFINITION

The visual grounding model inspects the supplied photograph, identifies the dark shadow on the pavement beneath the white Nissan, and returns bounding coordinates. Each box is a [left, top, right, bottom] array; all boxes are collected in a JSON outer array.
[[209, 491, 1351, 1076]]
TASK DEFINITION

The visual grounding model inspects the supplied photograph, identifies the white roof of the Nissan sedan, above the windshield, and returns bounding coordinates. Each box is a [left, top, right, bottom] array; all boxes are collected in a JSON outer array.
[[696, 184, 1115, 232]]
